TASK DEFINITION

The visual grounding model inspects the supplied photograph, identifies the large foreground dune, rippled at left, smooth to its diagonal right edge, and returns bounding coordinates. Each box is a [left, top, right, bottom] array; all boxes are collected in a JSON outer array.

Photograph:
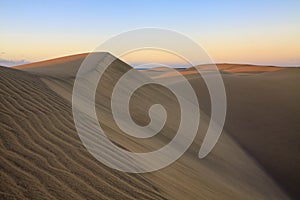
[[0, 55, 289, 199]]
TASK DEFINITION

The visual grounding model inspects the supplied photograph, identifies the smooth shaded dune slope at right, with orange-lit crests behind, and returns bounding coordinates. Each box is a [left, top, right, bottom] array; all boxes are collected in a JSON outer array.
[[154, 64, 300, 199]]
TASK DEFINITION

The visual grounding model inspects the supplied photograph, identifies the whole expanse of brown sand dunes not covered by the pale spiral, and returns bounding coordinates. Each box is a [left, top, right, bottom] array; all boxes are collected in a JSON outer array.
[[0, 53, 300, 200]]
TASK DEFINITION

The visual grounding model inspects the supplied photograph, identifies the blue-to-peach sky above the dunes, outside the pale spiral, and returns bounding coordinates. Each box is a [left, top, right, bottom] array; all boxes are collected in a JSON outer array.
[[0, 0, 300, 66]]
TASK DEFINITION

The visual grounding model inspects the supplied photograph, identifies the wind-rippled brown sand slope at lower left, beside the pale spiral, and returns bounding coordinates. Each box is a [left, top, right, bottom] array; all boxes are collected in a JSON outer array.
[[0, 65, 164, 199]]
